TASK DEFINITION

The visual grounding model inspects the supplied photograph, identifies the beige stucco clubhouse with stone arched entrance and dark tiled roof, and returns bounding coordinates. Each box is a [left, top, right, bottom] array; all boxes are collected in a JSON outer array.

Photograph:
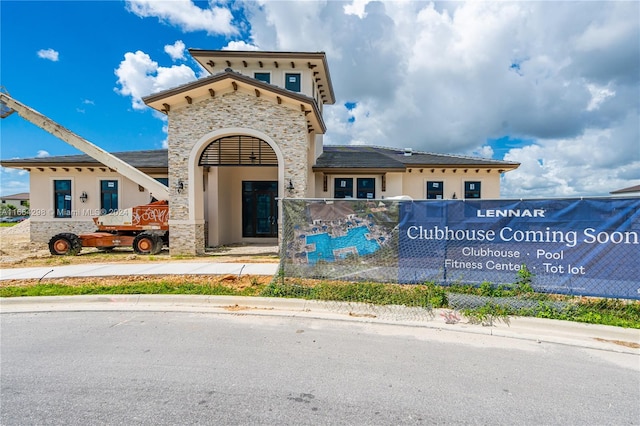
[[0, 49, 519, 254]]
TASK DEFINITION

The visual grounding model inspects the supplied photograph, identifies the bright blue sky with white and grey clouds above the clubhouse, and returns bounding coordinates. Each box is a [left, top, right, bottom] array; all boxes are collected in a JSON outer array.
[[0, 0, 640, 198]]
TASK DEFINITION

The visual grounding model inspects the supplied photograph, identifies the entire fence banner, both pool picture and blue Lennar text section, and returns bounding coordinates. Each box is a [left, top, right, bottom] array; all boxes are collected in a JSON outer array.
[[282, 198, 640, 299]]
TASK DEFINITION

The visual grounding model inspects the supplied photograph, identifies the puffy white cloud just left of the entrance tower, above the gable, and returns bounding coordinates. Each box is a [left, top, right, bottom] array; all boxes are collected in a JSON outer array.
[[115, 51, 196, 110]]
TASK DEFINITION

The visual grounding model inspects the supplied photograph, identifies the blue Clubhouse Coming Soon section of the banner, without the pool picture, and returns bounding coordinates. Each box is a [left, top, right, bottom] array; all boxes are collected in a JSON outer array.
[[398, 199, 640, 298]]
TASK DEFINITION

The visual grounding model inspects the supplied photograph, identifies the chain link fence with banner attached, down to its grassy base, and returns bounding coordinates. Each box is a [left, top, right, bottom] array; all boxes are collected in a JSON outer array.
[[273, 199, 640, 319]]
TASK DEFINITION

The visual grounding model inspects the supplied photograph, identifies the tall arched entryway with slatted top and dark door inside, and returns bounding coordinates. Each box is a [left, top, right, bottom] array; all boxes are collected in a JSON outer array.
[[186, 129, 283, 247]]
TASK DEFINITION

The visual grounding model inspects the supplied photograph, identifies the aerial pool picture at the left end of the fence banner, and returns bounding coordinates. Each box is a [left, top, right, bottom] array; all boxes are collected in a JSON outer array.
[[282, 199, 398, 282]]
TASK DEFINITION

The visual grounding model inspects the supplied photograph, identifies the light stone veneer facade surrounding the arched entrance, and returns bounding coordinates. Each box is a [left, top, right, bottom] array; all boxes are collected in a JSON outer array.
[[168, 92, 309, 255]]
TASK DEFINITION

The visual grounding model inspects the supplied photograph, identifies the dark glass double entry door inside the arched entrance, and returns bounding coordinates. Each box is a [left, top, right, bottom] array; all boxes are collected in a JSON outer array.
[[242, 181, 278, 238]]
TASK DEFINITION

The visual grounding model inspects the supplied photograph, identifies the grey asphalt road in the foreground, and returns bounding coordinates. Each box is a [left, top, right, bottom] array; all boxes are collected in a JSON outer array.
[[0, 311, 640, 425]]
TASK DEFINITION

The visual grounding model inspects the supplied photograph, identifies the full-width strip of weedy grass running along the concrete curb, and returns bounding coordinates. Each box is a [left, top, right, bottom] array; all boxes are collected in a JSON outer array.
[[0, 275, 640, 329]]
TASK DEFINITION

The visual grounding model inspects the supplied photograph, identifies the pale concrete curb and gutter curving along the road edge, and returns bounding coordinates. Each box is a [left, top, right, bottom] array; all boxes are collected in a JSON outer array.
[[0, 295, 640, 356]]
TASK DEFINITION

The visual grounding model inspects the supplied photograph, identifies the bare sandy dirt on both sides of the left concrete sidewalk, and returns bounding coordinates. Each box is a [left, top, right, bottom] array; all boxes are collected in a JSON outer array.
[[0, 220, 279, 289]]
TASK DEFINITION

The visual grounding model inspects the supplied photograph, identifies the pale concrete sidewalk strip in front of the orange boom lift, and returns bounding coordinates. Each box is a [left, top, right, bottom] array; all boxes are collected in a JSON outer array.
[[0, 262, 278, 280]]
